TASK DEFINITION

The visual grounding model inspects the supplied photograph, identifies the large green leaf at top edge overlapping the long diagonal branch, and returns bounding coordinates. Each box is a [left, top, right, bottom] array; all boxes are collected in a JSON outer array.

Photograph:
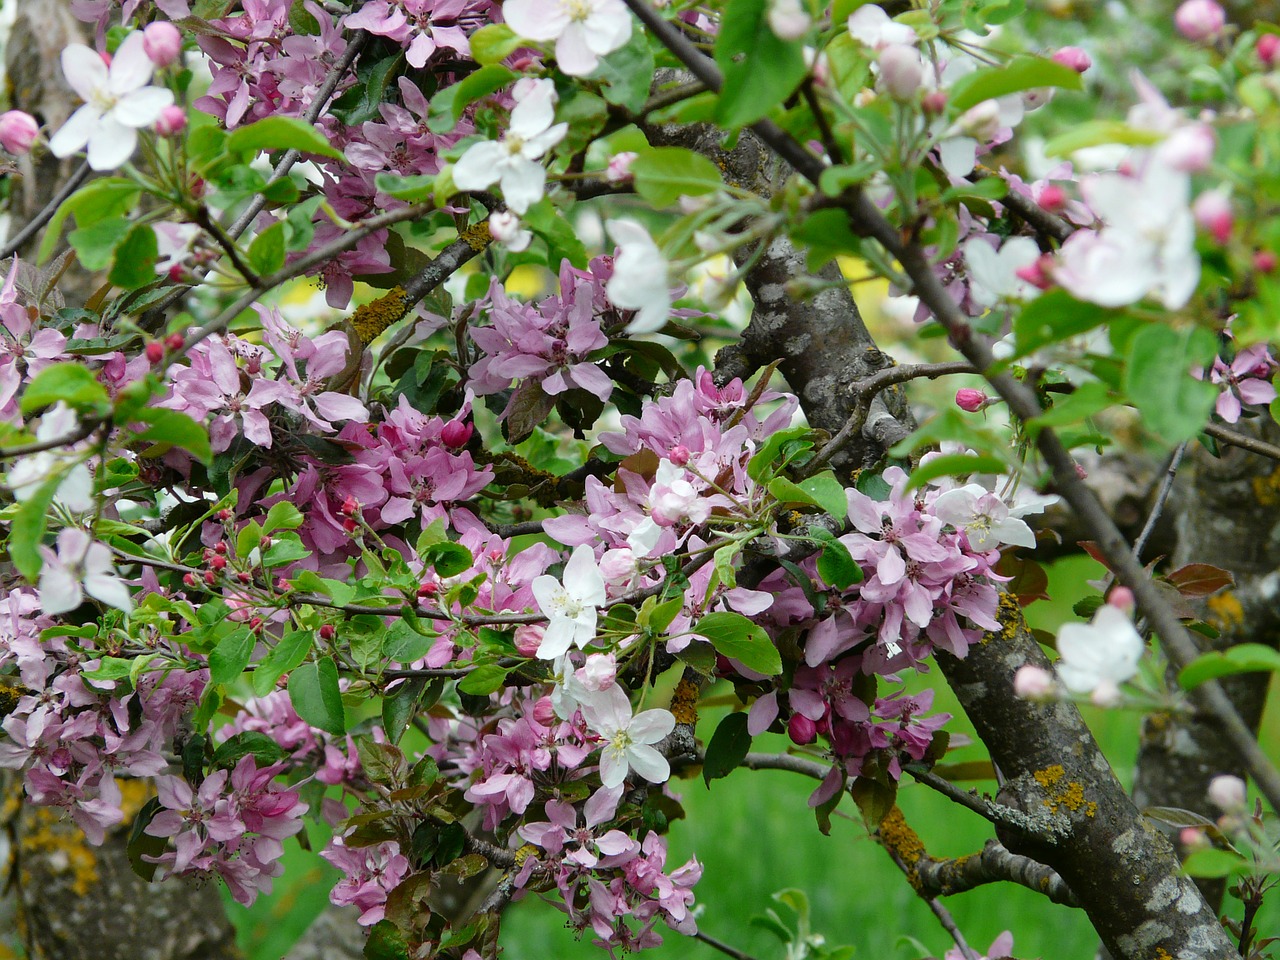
[[714, 0, 808, 127]]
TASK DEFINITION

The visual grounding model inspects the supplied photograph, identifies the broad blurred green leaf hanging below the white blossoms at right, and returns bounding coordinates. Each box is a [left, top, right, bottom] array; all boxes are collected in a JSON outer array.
[[1125, 323, 1219, 443]]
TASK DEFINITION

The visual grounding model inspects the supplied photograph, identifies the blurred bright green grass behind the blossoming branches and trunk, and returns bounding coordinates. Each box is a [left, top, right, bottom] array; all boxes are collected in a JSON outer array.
[[232, 557, 1280, 960]]
